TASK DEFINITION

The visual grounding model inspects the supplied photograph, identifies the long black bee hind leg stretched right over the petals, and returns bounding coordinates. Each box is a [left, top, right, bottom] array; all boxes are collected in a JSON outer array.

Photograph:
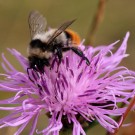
[[62, 47, 90, 65]]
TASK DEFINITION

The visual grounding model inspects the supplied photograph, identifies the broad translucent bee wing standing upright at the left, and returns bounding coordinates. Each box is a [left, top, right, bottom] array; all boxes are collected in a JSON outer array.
[[28, 11, 47, 38]]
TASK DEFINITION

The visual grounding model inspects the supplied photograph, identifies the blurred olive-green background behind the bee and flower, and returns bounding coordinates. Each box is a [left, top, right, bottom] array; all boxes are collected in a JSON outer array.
[[0, 0, 135, 135]]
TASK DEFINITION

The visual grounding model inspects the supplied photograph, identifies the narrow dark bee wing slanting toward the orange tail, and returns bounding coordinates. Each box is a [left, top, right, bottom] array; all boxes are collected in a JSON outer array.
[[47, 19, 76, 44]]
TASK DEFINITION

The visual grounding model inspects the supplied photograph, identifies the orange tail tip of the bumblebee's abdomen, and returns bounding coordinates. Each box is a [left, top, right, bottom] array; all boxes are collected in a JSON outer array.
[[65, 29, 81, 45]]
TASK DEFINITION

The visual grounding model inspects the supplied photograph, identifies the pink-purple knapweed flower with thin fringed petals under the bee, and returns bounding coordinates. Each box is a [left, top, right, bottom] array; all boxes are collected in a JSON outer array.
[[0, 33, 135, 135]]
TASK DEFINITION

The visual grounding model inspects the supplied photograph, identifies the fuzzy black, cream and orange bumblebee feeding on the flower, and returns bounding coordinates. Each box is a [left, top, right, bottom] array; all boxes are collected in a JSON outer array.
[[27, 11, 90, 72]]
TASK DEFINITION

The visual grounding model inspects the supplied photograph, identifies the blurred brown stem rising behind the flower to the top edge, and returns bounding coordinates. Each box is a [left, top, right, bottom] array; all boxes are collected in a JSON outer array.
[[85, 0, 107, 45]]
